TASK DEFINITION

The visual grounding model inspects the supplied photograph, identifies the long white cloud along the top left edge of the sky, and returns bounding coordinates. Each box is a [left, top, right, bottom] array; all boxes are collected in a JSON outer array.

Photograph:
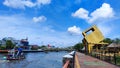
[[3, 0, 51, 9]]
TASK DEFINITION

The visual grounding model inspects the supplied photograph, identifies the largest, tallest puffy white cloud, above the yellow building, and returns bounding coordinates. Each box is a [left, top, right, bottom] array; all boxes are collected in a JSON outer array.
[[89, 3, 114, 23]]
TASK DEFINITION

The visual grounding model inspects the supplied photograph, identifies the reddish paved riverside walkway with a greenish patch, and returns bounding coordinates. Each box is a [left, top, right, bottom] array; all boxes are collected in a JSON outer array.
[[75, 52, 120, 68]]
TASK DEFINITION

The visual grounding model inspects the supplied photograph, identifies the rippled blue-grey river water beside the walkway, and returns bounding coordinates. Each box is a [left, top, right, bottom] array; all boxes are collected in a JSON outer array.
[[0, 51, 67, 68]]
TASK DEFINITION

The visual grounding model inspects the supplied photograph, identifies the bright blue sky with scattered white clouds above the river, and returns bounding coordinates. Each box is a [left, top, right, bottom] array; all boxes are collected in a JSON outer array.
[[0, 0, 120, 47]]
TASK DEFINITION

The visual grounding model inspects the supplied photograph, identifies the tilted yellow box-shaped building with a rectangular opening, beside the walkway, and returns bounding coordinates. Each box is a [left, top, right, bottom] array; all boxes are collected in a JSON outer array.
[[82, 25, 107, 53]]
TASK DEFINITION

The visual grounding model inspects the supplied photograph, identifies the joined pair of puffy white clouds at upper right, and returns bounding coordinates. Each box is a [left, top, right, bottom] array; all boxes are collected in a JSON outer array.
[[72, 3, 114, 23]]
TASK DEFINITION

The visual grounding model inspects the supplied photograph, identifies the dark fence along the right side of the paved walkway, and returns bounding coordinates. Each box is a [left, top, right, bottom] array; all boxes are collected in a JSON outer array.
[[90, 50, 120, 66]]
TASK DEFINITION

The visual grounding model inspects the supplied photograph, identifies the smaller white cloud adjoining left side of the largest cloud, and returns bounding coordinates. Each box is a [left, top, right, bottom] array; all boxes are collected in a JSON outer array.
[[72, 8, 89, 20]]
